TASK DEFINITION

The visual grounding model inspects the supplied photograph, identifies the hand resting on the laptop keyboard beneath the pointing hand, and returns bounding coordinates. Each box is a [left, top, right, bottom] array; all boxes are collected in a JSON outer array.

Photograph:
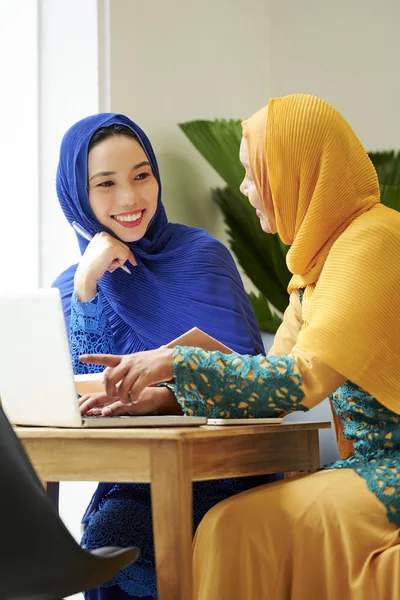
[[79, 387, 182, 417]]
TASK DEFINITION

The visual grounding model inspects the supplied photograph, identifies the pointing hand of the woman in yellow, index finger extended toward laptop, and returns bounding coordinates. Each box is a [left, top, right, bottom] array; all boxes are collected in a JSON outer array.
[[79, 346, 174, 404]]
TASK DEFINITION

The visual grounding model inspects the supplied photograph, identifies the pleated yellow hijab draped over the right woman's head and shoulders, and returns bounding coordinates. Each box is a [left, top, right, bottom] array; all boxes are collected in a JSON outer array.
[[243, 94, 400, 413]]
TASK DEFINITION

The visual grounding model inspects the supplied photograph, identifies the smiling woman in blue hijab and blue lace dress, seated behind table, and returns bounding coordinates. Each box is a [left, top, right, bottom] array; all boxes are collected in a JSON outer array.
[[54, 113, 276, 600]]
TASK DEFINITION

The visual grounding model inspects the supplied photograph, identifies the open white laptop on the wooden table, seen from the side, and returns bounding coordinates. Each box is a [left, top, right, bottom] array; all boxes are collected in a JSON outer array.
[[0, 289, 207, 428]]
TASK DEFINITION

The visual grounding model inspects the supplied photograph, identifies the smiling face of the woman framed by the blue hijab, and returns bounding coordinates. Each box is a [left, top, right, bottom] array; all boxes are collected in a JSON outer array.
[[88, 135, 158, 242]]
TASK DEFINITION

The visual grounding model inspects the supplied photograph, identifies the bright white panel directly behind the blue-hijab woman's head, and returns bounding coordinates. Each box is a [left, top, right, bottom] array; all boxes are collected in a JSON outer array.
[[39, 0, 99, 286]]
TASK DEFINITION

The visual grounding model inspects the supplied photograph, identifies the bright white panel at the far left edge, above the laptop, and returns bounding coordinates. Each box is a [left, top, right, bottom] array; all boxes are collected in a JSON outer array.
[[0, 0, 39, 292]]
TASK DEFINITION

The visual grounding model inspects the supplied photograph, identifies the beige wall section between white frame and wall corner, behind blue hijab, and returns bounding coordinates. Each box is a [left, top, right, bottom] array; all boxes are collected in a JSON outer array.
[[104, 0, 269, 234]]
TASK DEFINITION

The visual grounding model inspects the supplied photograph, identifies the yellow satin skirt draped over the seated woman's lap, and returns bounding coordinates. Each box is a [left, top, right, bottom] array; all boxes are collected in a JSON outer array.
[[193, 469, 400, 600]]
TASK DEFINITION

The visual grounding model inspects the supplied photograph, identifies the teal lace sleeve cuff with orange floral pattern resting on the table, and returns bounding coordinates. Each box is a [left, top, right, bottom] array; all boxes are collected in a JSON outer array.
[[174, 346, 308, 419]]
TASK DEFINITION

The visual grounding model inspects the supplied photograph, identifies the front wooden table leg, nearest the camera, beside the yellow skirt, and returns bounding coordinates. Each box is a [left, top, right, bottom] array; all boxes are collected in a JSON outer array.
[[151, 440, 193, 600]]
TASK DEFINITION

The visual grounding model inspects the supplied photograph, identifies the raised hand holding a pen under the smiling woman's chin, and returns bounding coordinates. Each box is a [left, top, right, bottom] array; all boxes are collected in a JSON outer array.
[[75, 231, 137, 302]]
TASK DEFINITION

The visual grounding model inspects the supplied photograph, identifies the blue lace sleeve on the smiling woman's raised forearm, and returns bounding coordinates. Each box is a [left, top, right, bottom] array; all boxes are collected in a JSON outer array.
[[69, 292, 116, 375]]
